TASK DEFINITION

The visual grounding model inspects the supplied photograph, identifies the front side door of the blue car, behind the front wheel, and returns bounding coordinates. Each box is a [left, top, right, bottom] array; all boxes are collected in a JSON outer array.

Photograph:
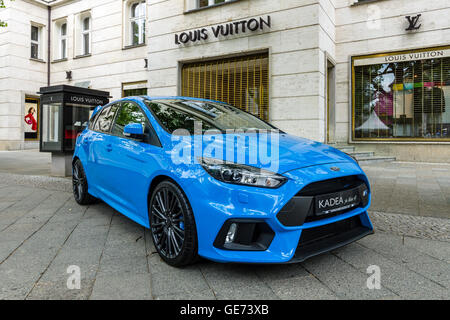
[[109, 101, 162, 221]]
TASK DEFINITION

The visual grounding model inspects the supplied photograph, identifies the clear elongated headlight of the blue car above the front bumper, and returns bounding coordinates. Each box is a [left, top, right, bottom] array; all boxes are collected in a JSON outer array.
[[198, 158, 287, 189]]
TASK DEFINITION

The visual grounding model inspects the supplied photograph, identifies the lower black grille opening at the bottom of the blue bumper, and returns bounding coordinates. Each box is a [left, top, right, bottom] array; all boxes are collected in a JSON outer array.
[[297, 216, 362, 250]]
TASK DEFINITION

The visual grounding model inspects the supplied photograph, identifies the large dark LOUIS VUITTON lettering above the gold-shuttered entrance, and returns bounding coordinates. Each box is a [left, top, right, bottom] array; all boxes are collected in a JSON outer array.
[[175, 16, 272, 45]]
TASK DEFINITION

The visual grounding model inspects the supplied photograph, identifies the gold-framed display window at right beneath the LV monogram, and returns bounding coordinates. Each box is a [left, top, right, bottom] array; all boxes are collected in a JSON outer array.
[[353, 49, 450, 140]]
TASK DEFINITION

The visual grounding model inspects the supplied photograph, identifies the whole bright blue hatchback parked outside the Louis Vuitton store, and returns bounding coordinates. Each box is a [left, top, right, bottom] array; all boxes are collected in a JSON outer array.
[[73, 96, 373, 267]]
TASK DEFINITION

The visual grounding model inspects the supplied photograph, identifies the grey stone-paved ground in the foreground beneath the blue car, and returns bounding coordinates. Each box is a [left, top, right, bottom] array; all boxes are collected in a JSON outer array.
[[0, 174, 450, 299]]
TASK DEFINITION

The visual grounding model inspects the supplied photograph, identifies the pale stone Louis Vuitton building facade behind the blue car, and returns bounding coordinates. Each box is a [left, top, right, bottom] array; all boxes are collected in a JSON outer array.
[[0, 0, 450, 162]]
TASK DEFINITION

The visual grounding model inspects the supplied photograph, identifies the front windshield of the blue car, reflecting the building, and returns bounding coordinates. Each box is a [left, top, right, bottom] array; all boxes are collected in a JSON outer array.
[[145, 100, 276, 134]]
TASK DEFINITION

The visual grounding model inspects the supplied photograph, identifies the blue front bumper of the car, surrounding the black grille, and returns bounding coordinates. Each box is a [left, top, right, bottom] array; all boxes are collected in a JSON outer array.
[[187, 162, 373, 264]]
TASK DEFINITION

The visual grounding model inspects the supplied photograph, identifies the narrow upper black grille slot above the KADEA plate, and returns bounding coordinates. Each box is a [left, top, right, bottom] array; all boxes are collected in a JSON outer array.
[[296, 176, 364, 197]]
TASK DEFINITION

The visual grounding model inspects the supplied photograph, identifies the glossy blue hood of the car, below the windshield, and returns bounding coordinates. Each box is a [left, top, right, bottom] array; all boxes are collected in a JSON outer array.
[[167, 133, 354, 173]]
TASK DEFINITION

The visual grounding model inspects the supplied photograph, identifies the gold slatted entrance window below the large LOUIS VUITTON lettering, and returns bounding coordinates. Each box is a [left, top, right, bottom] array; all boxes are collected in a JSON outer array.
[[181, 54, 269, 121]]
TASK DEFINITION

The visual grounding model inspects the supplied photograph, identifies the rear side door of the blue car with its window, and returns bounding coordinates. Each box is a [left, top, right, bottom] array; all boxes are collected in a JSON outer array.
[[88, 104, 120, 197]]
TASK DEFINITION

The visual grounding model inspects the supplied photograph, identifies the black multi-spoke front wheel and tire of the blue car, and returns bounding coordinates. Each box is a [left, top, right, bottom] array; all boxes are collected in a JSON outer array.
[[148, 180, 198, 267]]
